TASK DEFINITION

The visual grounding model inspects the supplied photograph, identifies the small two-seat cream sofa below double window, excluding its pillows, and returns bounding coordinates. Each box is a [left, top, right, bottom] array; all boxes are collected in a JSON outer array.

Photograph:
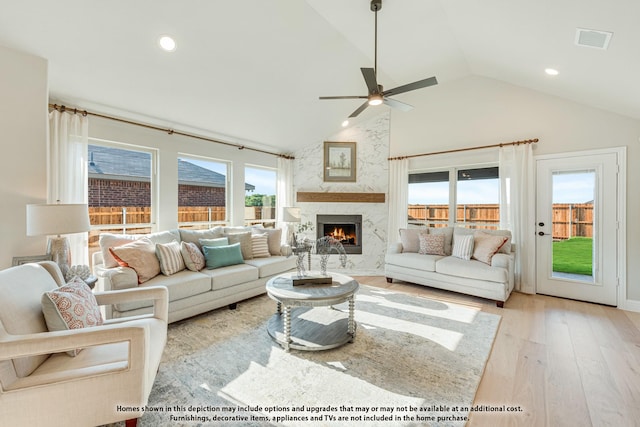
[[385, 227, 515, 307]]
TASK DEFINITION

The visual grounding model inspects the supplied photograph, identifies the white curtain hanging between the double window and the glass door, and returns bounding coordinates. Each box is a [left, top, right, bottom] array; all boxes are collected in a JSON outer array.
[[499, 144, 536, 293]]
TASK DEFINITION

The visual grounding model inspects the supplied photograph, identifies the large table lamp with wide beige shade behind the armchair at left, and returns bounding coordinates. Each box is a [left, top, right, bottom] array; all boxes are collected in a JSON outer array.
[[27, 203, 91, 273]]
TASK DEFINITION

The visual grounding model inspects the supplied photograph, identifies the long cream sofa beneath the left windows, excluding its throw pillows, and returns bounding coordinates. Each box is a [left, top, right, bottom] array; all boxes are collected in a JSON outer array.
[[93, 227, 296, 323]]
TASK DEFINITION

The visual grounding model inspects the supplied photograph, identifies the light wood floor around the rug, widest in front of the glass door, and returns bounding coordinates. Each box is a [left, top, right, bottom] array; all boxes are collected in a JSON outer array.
[[357, 276, 640, 427]]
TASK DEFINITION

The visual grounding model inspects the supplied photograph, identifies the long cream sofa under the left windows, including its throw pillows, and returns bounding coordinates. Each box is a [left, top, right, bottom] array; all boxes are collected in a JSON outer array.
[[93, 227, 295, 322]]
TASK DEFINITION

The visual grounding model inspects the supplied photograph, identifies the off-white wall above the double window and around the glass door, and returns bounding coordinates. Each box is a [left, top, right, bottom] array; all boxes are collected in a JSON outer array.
[[390, 77, 640, 301]]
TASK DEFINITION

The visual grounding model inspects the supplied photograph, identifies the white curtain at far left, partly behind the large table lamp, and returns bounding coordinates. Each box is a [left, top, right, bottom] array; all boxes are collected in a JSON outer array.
[[47, 110, 89, 265]]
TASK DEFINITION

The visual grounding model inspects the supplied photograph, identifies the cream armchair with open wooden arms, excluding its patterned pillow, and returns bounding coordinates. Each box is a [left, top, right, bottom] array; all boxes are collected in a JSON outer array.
[[0, 262, 168, 427]]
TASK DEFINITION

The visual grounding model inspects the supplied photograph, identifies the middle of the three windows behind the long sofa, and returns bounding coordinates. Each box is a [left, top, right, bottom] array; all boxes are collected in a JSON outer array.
[[178, 157, 229, 229]]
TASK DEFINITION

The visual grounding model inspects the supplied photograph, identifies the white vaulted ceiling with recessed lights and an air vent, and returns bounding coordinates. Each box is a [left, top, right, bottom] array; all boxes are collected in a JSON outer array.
[[0, 0, 640, 152]]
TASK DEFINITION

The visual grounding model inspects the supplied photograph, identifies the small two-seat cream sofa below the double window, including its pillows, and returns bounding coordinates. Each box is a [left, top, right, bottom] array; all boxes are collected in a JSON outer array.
[[385, 227, 515, 307]]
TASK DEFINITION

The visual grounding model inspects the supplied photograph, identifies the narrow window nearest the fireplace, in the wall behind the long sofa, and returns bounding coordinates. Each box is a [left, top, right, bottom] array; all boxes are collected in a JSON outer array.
[[244, 166, 276, 228]]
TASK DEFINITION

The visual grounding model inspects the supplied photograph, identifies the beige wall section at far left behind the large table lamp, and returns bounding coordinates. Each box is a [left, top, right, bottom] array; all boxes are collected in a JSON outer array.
[[0, 46, 48, 269]]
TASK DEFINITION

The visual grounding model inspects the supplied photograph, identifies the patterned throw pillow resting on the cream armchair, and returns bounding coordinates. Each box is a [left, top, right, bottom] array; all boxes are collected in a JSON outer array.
[[41, 276, 103, 356]]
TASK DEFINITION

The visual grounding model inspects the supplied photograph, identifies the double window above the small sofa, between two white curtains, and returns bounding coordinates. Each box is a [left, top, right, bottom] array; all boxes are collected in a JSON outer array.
[[408, 167, 500, 229]]
